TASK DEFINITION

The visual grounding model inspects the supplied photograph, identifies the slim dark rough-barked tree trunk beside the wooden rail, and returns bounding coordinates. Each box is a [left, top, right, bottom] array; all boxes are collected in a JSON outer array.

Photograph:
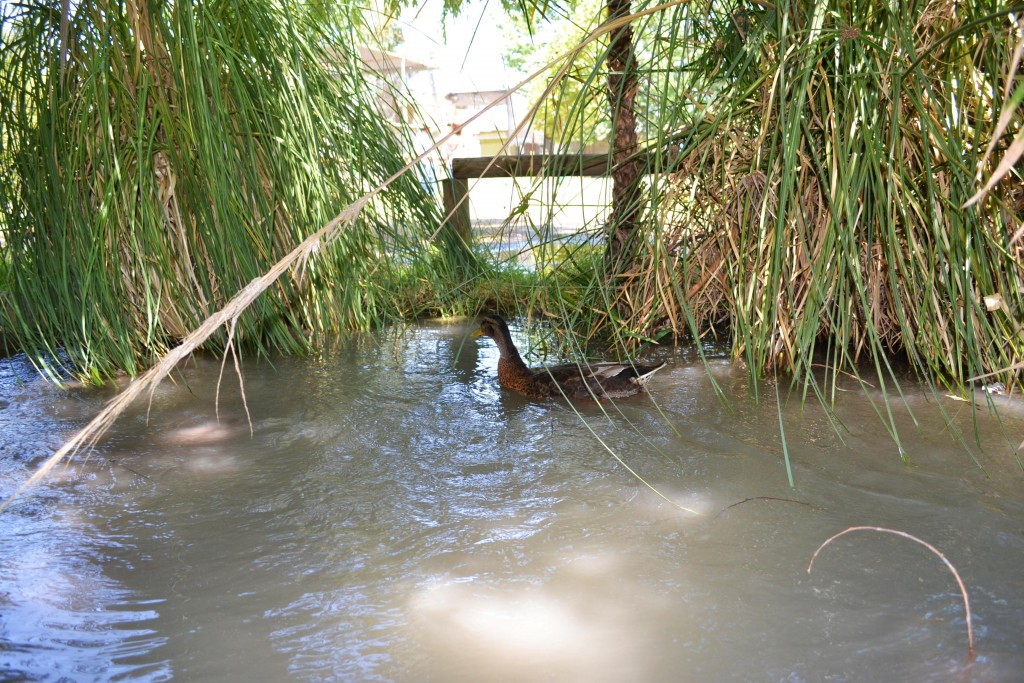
[[604, 0, 640, 305]]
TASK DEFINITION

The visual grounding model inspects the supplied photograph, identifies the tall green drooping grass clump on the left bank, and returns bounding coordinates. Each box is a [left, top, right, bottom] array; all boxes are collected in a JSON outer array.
[[0, 0, 477, 381]]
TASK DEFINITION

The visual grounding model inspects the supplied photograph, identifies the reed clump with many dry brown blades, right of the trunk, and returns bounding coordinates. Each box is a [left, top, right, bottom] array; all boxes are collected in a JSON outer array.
[[541, 0, 1024, 395]]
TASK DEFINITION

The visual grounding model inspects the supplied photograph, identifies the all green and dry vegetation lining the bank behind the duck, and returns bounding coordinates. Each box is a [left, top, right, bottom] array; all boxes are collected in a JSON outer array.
[[0, 0, 1024, 401]]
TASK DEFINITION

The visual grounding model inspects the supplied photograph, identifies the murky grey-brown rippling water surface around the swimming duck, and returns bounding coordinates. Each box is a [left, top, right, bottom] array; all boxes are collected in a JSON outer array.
[[0, 325, 1024, 681]]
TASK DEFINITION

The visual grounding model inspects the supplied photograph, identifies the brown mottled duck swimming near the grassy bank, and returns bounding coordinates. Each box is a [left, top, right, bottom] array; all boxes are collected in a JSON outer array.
[[471, 313, 666, 400]]
